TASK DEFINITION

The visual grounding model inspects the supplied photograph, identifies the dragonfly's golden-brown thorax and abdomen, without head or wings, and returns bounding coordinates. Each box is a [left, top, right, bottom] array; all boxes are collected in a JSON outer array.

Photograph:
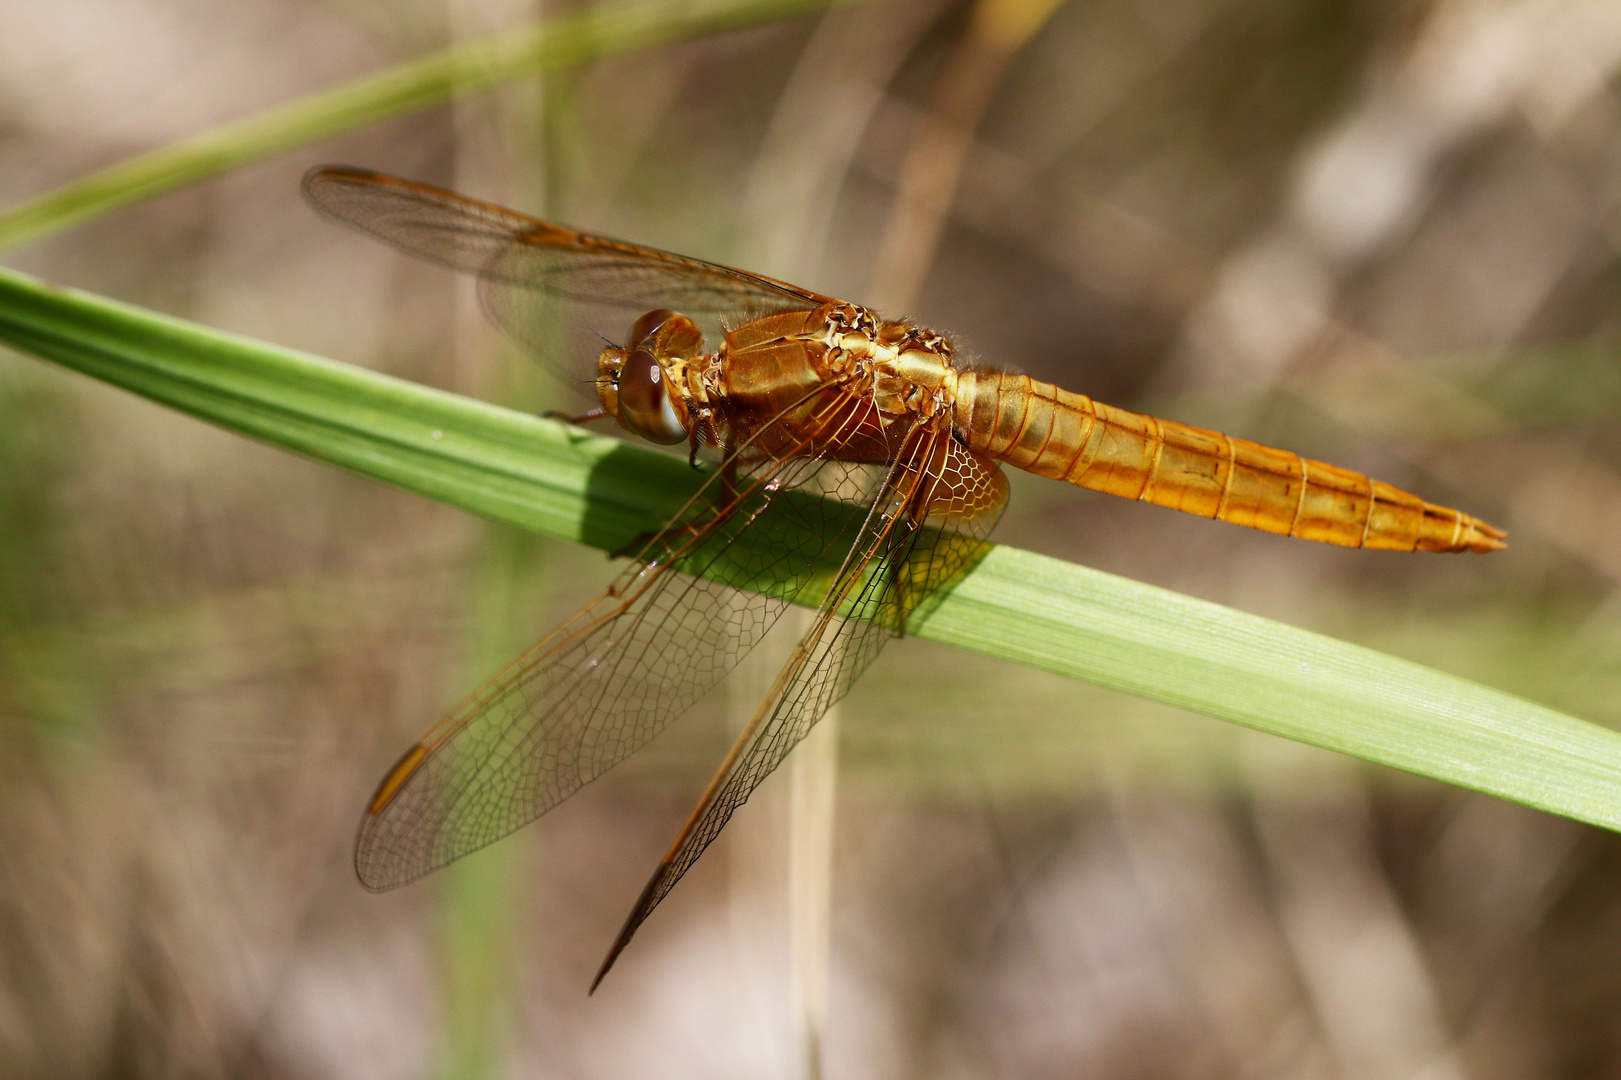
[[625, 303, 1504, 551]]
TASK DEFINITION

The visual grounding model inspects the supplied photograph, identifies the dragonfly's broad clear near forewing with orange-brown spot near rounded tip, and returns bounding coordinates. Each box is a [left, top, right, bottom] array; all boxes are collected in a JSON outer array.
[[355, 387, 877, 890]]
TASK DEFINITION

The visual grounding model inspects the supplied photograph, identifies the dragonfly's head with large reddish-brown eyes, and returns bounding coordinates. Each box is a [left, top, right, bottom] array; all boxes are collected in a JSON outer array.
[[597, 308, 704, 446]]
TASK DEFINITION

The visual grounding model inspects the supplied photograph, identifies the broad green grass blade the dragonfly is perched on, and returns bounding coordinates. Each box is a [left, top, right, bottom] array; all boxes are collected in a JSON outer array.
[[0, 262, 1621, 829]]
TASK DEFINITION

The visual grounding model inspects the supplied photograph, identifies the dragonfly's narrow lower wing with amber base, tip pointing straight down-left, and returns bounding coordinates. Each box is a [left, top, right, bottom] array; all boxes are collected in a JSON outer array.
[[592, 430, 1007, 989]]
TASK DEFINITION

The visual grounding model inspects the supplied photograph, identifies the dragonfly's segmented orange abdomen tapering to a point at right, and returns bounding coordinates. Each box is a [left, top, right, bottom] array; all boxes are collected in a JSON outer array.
[[953, 371, 1506, 551]]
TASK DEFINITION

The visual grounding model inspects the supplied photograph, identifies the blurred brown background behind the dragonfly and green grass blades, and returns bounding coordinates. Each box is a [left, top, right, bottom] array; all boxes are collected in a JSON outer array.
[[0, 0, 1621, 1080]]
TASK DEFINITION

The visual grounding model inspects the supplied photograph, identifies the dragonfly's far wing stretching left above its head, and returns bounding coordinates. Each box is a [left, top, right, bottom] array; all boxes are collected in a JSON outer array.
[[303, 165, 828, 316]]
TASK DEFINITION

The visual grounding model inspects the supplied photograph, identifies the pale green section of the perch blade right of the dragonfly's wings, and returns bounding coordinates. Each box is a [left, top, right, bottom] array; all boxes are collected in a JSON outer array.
[[917, 546, 1621, 829]]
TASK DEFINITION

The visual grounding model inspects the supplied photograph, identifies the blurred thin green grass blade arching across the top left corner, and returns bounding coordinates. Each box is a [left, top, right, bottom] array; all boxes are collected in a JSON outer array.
[[0, 0, 840, 248]]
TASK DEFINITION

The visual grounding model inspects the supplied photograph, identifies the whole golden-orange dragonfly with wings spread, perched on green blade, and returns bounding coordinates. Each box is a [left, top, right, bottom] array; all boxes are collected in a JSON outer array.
[[303, 165, 1506, 991]]
